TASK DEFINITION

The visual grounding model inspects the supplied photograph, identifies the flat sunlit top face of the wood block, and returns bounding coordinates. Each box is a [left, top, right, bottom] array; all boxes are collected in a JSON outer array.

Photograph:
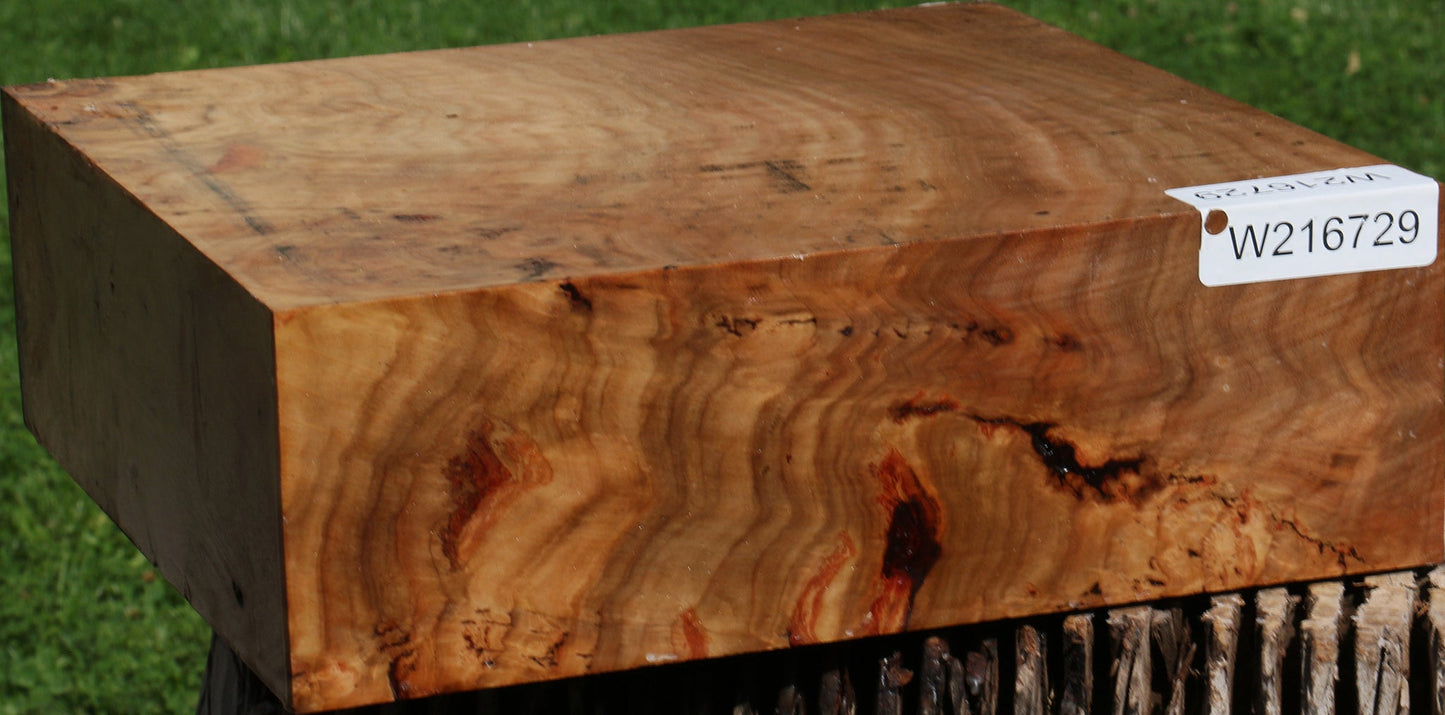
[[0, 3, 1379, 309]]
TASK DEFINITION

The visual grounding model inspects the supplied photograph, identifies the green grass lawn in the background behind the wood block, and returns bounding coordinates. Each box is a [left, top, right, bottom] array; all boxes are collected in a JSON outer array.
[[0, 0, 1445, 715]]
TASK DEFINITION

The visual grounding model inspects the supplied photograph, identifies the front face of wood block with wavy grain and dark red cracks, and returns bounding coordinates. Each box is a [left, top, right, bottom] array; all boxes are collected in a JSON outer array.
[[276, 217, 1445, 711]]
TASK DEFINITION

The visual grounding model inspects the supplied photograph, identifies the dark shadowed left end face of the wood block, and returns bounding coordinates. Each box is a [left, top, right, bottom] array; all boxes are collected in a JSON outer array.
[[3, 94, 289, 695]]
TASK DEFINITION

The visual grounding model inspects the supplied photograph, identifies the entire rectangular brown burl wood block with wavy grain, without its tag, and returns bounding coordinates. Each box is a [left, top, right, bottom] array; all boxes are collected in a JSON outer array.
[[4, 4, 1445, 711]]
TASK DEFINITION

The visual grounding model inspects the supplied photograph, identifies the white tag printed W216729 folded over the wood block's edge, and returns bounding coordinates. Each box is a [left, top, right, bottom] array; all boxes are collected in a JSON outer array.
[[1165, 165, 1439, 286]]
